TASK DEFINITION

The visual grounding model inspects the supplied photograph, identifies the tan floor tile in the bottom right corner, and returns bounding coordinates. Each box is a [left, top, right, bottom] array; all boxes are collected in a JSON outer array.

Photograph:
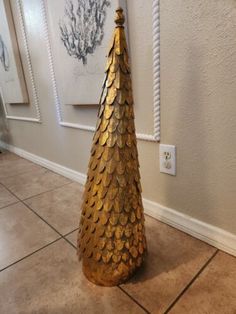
[[170, 252, 236, 314]]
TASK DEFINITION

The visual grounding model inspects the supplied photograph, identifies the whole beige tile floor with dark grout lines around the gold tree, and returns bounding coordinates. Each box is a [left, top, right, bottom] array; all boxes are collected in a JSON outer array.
[[0, 152, 236, 314]]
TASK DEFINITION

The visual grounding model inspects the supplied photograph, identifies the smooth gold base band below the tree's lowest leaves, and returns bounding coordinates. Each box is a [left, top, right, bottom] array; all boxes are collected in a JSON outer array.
[[83, 258, 139, 287]]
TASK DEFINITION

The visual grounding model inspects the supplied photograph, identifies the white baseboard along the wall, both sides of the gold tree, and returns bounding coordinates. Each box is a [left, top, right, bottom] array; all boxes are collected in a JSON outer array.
[[0, 141, 236, 256]]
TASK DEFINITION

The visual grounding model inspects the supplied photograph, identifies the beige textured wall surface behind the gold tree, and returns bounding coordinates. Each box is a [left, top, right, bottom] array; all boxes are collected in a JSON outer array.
[[0, 0, 236, 233]]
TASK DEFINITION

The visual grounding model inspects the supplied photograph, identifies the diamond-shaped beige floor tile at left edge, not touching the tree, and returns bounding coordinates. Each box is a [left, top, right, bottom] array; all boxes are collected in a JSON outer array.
[[1, 168, 71, 200]]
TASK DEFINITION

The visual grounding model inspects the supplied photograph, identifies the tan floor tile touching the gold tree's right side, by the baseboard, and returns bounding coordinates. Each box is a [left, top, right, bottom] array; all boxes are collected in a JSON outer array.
[[122, 217, 216, 313]]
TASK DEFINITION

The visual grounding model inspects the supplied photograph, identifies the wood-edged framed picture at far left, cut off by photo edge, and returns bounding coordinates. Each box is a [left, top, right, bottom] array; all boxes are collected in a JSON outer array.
[[0, 0, 28, 104]]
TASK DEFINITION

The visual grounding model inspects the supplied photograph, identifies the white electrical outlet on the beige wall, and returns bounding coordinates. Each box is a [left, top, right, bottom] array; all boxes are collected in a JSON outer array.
[[160, 144, 176, 176]]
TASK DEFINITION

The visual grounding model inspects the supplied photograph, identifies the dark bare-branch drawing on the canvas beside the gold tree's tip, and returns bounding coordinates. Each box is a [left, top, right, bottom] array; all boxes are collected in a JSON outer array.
[[59, 0, 110, 64]]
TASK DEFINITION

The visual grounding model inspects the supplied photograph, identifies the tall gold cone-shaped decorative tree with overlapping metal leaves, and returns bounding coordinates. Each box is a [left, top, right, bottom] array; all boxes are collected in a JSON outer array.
[[78, 8, 146, 286]]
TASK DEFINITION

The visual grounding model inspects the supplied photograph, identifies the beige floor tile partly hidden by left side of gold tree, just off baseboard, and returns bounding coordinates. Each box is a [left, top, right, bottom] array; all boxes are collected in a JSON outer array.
[[25, 183, 83, 234]]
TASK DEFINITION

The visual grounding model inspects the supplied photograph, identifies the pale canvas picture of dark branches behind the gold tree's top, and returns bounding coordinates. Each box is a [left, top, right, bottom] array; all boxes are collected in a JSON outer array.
[[46, 0, 126, 105]]
